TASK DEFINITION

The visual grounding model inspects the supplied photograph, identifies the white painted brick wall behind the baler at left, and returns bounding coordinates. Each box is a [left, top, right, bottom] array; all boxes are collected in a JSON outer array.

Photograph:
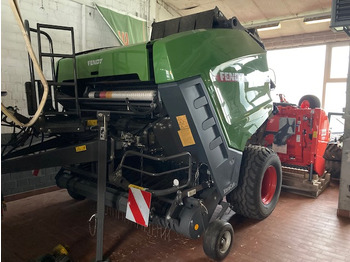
[[1, 0, 173, 196]]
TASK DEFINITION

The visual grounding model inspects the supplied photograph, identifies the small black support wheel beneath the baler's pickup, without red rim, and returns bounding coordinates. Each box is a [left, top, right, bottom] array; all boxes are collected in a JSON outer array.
[[203, 220, 233, 261]]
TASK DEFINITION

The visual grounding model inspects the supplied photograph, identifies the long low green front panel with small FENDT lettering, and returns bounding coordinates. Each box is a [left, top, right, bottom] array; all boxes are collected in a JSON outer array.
[[57, 43, 150, 82]]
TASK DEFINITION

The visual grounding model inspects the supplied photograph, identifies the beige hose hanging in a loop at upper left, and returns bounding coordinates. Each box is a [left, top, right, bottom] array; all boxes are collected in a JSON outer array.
[[1, 0, 49, 127]]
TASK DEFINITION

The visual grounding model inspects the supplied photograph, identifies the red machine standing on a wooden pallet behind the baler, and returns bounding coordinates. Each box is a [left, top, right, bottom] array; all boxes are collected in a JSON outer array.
[[264, 95, 330, 197]]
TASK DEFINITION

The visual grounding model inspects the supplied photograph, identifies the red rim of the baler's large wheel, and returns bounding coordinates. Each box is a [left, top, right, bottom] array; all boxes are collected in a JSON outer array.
[[261, 166, 277, 205]]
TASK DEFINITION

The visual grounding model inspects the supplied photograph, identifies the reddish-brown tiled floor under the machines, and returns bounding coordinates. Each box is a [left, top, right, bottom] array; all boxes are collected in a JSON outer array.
[[1, 184, 350, 262]]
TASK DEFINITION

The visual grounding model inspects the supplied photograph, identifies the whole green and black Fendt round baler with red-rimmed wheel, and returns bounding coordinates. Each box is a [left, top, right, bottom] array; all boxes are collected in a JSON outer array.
[[3, 9, 281, 260]]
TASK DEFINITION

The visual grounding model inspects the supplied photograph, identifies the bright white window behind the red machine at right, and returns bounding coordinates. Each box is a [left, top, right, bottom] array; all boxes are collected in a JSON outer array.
[[267, 43, 350, 116]]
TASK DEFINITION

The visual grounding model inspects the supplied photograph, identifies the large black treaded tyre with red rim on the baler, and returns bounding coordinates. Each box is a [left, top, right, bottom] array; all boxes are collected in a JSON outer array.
[[226, 145, 282, 220]]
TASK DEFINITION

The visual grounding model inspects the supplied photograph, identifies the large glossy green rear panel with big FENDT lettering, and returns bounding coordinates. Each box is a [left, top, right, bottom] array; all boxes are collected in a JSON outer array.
[[153, 29, 273, 151]]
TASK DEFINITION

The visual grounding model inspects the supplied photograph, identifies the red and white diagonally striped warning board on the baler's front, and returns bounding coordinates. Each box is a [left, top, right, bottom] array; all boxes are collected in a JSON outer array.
[[125, 185, 152, 227]]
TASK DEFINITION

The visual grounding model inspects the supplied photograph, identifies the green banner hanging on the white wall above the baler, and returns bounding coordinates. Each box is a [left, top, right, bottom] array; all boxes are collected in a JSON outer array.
[[95, 4, 148, 45]]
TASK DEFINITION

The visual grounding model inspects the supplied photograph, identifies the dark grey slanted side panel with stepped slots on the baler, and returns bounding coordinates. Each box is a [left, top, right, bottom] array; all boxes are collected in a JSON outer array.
[[159, 77, 242, 197]]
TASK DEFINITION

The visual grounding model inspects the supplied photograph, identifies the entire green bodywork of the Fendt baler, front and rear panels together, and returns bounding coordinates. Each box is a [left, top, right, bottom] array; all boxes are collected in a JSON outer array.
[[57, 29, 273, 151]]
